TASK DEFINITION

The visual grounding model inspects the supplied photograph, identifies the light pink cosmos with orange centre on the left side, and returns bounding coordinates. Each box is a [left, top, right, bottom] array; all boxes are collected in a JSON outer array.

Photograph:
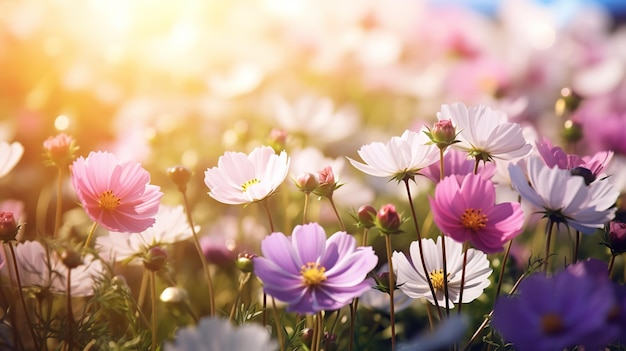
[[71, 152, 163, 233]]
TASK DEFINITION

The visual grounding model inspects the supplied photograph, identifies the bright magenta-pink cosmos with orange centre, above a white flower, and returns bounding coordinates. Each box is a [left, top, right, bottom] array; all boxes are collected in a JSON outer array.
[[429, 174, 524, 253]]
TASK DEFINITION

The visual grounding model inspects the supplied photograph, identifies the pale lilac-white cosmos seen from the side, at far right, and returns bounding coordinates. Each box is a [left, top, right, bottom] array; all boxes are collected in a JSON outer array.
[[509, 157, 619, 234]]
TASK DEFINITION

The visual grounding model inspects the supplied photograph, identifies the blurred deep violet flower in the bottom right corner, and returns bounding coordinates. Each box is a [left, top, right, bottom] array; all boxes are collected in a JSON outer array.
[[492, 262, 618, 351]]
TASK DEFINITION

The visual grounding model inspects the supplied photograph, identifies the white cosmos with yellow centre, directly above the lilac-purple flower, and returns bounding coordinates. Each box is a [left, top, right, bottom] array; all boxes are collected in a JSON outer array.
[[204, 146, 289, 205]]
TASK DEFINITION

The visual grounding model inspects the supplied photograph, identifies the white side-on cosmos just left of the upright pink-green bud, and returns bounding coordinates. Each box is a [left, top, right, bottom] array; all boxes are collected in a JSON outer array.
[[348, 129, 439, 181]]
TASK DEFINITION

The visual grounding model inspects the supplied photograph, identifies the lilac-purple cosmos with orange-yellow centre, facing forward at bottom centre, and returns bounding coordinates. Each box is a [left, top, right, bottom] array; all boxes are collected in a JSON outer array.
[[254, 223, 378, 314]]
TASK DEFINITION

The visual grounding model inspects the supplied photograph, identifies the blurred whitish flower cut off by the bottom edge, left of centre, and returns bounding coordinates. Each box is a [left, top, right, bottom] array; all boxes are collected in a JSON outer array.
[[163, 317, 278, 351]]
